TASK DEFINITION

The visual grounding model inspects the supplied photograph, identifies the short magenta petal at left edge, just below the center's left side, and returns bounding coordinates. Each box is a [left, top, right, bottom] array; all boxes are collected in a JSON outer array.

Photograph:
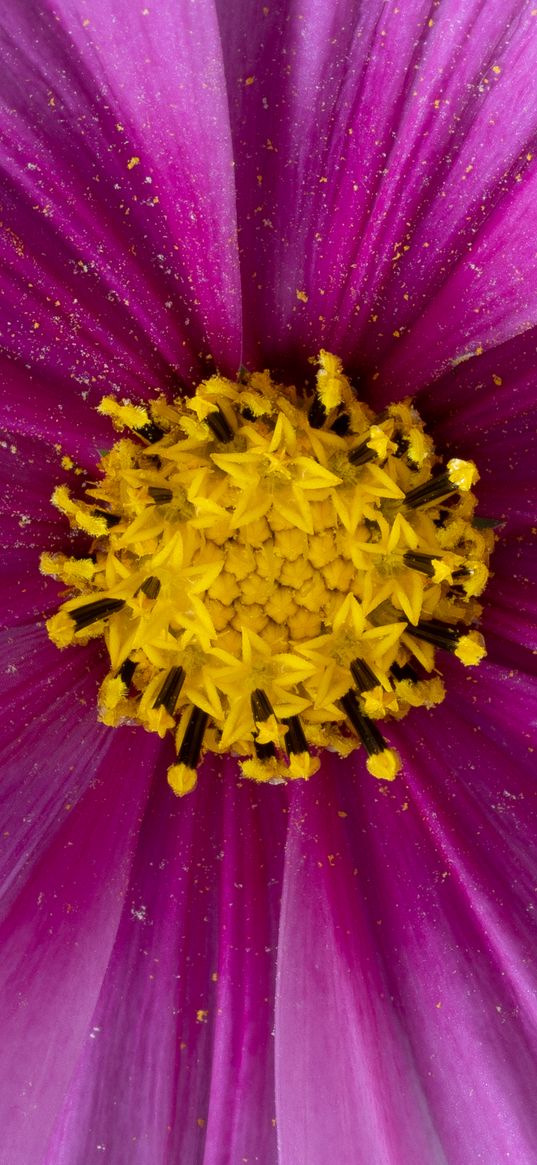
[[0, 627, 112, 916]]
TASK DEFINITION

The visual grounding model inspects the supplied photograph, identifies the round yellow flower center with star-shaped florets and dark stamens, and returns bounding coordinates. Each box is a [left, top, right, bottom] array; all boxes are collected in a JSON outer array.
[[41, 352, 494, 795]]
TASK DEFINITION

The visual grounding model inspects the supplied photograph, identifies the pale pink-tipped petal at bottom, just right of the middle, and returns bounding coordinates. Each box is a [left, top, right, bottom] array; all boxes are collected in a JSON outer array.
[[276, 762, 441, 1165]]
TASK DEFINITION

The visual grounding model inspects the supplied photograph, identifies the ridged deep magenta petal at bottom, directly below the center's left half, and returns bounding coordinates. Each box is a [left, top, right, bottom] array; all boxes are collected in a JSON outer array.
[[45, 764, 287, 1165]]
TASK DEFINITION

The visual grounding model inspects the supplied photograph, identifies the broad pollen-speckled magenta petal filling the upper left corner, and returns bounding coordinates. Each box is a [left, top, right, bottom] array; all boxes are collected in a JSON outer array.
[[0, 0, 240, 445]]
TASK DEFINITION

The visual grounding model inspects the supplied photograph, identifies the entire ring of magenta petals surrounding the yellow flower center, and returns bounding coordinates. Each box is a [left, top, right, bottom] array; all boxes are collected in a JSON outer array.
[[0, 0, 537, 1165]]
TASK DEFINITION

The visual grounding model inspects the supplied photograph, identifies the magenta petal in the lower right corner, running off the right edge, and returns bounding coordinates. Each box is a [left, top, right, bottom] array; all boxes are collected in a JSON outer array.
[[372, 665, 537, 1165]]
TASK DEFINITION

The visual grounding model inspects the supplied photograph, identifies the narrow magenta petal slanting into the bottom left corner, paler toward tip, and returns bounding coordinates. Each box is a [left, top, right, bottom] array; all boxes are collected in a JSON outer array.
[[0, 733, 155, 1165]]
